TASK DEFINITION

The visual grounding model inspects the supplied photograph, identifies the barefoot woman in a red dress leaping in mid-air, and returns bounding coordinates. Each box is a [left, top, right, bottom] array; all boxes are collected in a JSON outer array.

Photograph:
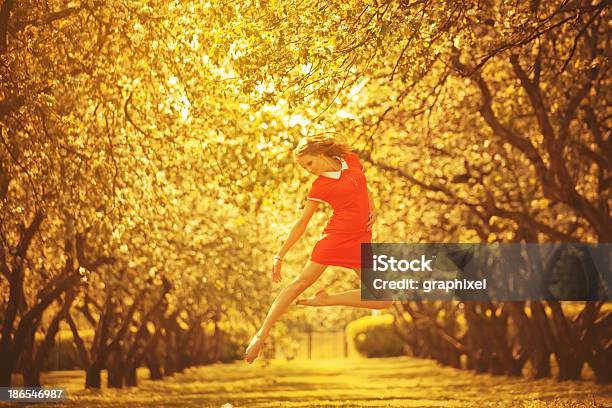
[[245, 135, 391, 363]]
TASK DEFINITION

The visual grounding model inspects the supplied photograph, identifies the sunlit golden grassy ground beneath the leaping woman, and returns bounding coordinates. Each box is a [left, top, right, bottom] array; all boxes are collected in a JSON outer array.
[[4, 357, 612, 408]]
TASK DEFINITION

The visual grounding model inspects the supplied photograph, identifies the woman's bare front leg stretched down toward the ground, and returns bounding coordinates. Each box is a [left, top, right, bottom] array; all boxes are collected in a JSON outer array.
[[245, 261, 327, 363]]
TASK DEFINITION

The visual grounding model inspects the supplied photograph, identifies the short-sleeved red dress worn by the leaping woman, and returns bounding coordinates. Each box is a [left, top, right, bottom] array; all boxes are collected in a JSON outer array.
[[307, 153, 372, 268]]
